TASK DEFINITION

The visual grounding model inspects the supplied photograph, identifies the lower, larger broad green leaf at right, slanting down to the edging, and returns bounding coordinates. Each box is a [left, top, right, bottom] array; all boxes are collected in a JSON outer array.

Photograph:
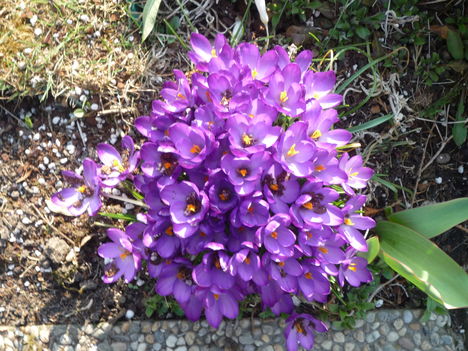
[[375, 221, 468, 308]]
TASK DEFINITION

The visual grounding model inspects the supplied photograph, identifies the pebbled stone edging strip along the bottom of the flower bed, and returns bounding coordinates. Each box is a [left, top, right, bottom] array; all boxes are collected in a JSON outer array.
[[0, 310, 464, 351]]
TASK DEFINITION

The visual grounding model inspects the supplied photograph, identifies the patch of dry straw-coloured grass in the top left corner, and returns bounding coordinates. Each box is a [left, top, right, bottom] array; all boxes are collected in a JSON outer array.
[[0, 0, 148, 99]]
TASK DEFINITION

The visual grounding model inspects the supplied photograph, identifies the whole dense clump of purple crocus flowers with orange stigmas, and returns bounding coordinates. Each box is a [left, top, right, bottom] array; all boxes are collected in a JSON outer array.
[[52, 34, 375, 351]]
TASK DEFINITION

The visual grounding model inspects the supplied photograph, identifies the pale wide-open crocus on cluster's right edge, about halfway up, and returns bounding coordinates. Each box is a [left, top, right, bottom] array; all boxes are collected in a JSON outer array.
[[340, 153, 374, 195]]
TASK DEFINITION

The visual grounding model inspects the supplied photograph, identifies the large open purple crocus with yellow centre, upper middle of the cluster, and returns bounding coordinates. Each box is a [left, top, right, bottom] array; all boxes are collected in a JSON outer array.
[[226, 115, 281, 157]]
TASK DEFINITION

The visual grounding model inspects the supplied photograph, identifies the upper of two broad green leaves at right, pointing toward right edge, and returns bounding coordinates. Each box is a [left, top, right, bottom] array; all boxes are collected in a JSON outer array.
[[388, 197, 468, 239]]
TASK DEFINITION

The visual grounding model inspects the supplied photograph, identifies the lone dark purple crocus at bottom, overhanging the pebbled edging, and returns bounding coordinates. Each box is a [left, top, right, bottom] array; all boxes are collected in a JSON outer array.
[[284, 313, 327, 351]]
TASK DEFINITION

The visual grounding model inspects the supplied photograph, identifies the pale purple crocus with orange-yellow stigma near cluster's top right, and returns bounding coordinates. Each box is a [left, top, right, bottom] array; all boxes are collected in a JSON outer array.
[[265, 63, 305, 117]]
